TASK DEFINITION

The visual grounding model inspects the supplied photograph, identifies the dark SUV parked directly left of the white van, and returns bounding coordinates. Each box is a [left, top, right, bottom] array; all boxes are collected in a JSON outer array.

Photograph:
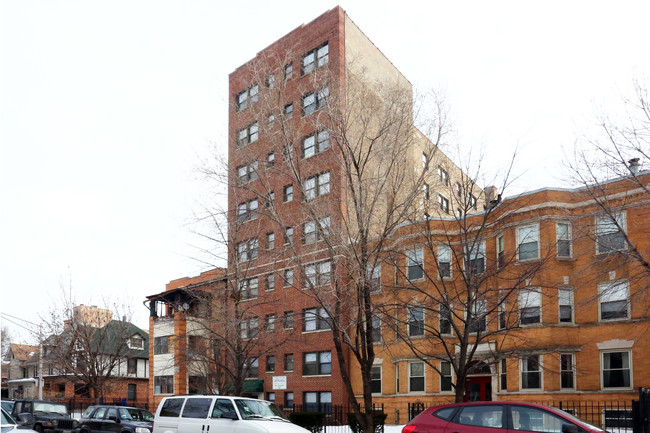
[[77, 406, 153, 433]]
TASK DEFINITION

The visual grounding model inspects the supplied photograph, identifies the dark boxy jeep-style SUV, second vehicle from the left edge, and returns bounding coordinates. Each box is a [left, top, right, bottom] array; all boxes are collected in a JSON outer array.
[[11, 400, 77, 433]]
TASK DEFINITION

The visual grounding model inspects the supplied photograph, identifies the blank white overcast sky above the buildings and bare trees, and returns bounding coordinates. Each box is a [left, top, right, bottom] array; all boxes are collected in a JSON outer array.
[[0, 0, 650, 340]]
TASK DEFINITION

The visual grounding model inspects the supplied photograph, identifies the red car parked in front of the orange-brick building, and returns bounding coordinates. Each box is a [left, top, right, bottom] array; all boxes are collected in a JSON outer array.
[[402, 402, 604, 433]]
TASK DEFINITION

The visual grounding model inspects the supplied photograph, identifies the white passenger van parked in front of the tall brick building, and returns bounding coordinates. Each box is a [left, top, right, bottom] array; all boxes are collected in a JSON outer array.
[[153, 395, 309, 433]]
